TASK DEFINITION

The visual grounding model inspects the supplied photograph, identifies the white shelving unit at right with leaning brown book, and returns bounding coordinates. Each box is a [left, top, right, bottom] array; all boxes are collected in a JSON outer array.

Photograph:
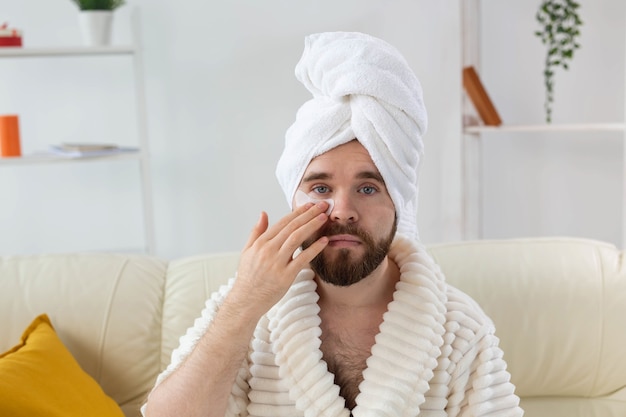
[[460, 0, 626, 247]]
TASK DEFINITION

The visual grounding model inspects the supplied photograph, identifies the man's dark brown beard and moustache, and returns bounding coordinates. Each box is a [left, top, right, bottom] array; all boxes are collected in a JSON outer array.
[[302, 218, 398, 287]]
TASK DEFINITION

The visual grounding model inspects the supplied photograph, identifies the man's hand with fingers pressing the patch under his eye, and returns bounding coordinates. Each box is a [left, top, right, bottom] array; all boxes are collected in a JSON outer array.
[[230, 201, 328, 317]]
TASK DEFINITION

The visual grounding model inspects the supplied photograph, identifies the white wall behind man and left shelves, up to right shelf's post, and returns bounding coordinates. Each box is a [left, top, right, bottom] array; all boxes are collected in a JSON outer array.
[[0, 0, 461, 258]]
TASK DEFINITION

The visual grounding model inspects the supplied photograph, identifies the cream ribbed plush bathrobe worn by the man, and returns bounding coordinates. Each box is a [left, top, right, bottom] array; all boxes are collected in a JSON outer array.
[[149, 236, 523, 417]]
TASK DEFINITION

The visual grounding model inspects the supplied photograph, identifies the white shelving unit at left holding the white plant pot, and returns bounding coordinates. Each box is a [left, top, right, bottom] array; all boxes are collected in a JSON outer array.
[[0, 13, 155, 254]]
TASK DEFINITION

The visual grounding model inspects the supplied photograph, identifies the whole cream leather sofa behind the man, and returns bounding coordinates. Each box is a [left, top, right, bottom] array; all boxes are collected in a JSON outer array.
[[0, 238, 626, 417]]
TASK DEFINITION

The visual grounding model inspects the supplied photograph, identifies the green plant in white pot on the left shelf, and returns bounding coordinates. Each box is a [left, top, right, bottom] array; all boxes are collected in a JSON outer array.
[[72, 0, 125, 46]]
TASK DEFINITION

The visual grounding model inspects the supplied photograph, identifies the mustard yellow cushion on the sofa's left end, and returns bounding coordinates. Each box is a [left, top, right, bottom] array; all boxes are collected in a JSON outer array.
[[0, 314, 124, 417]]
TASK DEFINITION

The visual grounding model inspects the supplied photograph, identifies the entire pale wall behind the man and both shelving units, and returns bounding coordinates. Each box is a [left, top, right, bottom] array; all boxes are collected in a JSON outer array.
[[0, 0, 626, 258]]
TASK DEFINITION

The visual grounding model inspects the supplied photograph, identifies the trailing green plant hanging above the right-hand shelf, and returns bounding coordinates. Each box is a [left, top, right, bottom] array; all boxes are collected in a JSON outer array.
[[535, 0, 583, 123]]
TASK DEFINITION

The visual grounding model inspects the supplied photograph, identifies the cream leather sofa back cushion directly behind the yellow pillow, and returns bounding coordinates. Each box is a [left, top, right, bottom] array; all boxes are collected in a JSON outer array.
[[0, 254, 167, 417]]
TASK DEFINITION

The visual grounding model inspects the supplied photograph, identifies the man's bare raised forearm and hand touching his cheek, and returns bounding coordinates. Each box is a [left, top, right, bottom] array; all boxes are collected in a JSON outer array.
[[145, 202, 328, 417]]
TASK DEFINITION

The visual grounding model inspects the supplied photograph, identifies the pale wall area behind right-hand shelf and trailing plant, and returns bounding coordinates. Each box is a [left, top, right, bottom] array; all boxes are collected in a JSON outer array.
[[481, 0, 626, 246]]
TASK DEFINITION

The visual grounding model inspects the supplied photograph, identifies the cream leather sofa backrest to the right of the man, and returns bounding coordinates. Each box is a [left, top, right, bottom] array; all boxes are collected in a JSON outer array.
[[429, 238, 626, 417]]
